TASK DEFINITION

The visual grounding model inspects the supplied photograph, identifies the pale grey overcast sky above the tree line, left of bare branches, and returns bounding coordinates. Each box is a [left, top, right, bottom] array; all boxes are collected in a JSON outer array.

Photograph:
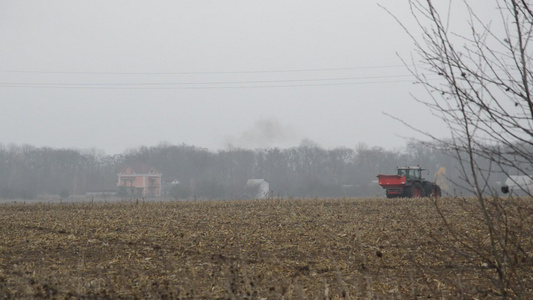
[[0, 0, 490, 153]]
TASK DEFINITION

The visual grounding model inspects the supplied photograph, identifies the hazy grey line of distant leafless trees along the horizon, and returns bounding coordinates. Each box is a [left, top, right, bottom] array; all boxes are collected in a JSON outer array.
[[0, 141, 508, 199]]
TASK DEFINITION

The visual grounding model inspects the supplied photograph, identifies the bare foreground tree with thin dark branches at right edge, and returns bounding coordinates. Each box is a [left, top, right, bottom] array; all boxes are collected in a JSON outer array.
[[386, 0, 533, 299]]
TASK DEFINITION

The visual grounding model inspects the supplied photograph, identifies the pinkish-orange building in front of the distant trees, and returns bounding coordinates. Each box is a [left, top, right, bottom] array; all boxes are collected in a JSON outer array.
[[117, 163, 161, 197]]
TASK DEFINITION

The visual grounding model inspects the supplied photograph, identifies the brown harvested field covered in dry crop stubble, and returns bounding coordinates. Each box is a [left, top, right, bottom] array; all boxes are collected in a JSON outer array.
[[0, 199, 533, 299]]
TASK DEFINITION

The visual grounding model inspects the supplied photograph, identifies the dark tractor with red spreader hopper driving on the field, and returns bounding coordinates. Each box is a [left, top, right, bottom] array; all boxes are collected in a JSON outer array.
[[378, 166, 441, 198]]
